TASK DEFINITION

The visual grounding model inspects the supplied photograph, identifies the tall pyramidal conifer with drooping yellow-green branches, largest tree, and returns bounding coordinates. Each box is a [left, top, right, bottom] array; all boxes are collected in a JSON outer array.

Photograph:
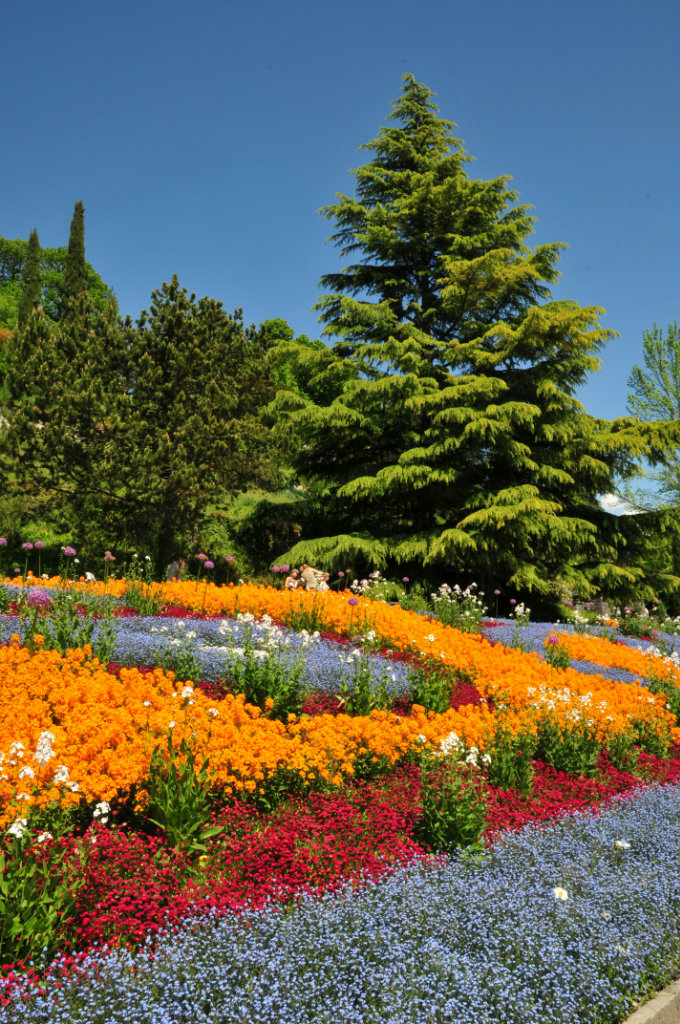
[[280, 75, 655, 594]]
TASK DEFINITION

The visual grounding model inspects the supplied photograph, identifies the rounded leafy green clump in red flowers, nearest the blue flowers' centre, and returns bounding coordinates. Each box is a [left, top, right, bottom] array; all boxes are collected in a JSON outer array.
[[414, 763, 486, 853]]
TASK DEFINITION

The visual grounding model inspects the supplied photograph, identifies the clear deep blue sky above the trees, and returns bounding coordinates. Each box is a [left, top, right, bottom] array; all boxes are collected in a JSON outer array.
[[0, 0, 680, 417]]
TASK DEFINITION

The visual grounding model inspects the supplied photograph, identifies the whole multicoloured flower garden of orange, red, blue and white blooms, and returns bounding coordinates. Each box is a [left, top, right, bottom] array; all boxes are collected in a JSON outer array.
[[0, 574, 680, 1024]]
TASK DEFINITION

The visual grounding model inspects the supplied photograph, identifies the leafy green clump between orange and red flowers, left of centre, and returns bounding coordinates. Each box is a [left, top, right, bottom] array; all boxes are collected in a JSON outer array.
[[143, 729, 223, 856]]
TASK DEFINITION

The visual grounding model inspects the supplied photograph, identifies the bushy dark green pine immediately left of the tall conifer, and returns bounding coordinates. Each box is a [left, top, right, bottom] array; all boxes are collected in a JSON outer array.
[[120, 278, 277, 561]]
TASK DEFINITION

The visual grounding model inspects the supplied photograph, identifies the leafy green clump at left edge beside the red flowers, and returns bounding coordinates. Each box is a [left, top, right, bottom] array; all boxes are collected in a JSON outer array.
[[0, 819, 85, 964]]
